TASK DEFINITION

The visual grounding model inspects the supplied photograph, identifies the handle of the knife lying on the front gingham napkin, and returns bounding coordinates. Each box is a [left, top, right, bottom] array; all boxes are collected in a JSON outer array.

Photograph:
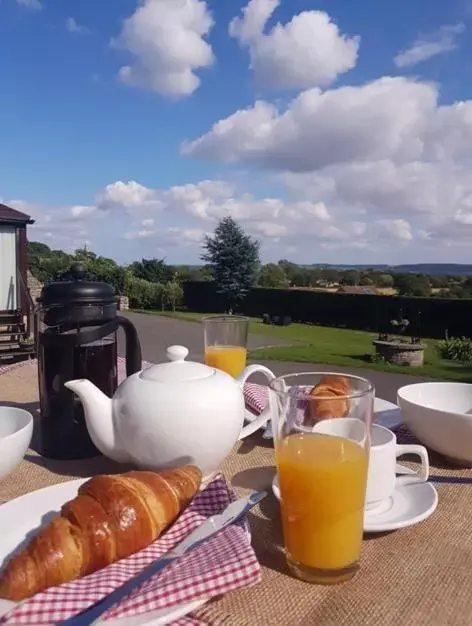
[[60, 555, 178, 626]]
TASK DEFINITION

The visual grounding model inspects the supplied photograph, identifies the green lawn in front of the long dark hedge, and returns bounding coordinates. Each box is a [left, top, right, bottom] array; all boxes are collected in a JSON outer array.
[[134, 311, 472, 382]]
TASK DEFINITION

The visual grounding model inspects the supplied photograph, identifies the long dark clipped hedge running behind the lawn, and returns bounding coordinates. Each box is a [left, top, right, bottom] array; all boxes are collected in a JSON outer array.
[[183, 282, 472, 338]]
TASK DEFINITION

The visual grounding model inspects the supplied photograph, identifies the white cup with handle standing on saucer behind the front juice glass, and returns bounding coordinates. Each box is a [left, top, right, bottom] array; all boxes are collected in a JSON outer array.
[[365, 424, 429, 511]]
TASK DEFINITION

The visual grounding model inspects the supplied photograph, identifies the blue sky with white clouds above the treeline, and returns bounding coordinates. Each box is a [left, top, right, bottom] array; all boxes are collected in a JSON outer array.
[[0, 0, 472, 264]]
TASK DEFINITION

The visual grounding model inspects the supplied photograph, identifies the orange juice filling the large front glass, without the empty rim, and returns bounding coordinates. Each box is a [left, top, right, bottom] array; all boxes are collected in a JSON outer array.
[[277, 434, 368, 572]]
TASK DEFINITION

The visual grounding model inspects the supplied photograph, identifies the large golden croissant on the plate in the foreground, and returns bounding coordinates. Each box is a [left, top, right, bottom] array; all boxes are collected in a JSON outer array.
[[0, 465, 202, 601]]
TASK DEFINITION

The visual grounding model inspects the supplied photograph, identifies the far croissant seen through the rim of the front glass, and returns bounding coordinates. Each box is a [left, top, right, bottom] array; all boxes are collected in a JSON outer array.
[[308, 374, 352, 423]]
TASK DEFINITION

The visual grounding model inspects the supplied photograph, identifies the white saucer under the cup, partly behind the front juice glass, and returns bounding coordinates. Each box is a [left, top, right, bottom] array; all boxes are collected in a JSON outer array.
[[272, 465, 438, 533]]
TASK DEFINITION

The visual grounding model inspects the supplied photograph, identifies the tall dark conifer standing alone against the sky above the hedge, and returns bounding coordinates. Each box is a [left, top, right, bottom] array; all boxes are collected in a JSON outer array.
[[202, 217, 260, 311]]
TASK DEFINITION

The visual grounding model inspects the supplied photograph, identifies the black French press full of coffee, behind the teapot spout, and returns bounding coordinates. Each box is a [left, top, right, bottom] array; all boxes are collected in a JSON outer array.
[[35, 264, 141, 459]]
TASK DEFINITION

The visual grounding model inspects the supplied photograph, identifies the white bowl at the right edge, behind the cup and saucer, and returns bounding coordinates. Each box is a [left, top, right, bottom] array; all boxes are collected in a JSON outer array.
[[397, 382, 472, 465]]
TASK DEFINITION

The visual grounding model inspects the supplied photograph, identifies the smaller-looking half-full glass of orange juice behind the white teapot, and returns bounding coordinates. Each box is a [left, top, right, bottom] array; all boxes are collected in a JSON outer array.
[[203, 315, 249, 377]]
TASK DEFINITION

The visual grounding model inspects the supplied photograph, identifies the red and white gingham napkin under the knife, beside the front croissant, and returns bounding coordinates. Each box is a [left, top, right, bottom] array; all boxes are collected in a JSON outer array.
[[0, 475, 261, 626]]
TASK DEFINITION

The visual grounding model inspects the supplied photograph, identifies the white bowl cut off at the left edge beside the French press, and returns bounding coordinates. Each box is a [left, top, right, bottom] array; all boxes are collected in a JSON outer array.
[[0, 406, 33, 479]]
